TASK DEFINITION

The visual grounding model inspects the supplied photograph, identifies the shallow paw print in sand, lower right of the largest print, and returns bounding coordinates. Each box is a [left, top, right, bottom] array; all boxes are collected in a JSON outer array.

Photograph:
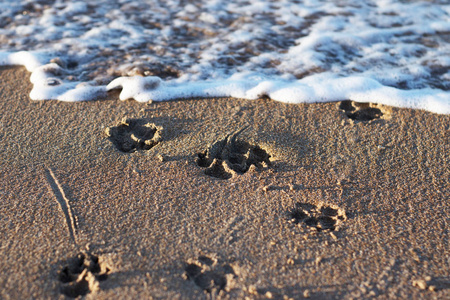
[[289, 202, 347, 231]]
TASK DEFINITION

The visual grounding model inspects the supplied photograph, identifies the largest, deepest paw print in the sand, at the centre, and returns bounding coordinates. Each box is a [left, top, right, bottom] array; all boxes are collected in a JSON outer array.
[[196, 129, 270, 179]]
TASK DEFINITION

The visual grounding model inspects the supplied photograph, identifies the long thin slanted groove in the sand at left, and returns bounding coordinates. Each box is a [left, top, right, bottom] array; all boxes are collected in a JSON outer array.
[[47, 168, 77, 245]]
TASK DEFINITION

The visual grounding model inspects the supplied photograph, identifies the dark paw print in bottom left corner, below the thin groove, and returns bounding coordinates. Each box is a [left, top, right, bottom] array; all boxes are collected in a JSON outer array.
[[58, 253, 110, 298]]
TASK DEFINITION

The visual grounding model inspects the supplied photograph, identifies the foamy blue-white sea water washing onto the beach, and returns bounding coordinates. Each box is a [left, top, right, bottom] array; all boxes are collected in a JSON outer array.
[[0, 0, 450, 114]]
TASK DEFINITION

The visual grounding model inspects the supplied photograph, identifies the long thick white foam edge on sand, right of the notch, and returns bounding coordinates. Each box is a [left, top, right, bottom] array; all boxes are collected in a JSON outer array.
[[107, 75, 450, 114]]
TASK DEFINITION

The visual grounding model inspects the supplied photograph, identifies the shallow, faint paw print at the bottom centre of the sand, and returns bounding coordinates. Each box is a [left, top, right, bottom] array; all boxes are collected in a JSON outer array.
[[184, 255, 236, 293]]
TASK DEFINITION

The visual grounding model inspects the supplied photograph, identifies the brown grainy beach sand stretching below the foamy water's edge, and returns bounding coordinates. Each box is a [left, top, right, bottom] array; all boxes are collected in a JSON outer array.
[[0, 68, 450, 299]]
